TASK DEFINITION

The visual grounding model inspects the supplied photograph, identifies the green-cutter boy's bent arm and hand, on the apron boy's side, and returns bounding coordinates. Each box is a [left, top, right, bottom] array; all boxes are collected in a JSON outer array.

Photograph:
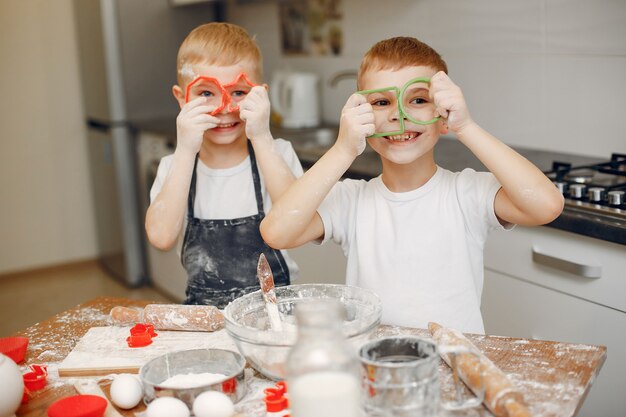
[[261, 94, 374, 249]]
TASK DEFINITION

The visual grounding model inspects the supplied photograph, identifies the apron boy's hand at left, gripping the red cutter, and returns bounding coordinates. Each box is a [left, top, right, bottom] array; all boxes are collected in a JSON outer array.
[[176, 97, 219, 156]]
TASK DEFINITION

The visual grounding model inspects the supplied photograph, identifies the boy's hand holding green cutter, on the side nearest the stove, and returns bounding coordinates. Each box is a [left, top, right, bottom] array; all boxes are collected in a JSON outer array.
[[430, 71, 474, 132]]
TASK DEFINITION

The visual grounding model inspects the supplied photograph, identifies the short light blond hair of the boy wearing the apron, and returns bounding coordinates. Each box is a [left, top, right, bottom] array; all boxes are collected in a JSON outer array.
[[176, 22, 263, 86]]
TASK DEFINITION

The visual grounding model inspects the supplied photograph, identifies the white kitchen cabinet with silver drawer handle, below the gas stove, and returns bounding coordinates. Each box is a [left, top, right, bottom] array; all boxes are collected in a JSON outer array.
[[482, 227, 626, 417]]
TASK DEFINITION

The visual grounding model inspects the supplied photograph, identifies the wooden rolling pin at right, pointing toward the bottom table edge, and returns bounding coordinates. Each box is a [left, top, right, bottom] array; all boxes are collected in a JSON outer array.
[[428, 323, 531, 417]]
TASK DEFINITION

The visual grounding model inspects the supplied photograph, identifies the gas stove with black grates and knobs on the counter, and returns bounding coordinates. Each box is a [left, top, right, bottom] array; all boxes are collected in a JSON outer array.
[[546, 153, 626, 220]]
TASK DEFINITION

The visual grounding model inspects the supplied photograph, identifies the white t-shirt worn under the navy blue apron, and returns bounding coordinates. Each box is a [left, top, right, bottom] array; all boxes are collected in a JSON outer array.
[[150, 139, 302, 281]]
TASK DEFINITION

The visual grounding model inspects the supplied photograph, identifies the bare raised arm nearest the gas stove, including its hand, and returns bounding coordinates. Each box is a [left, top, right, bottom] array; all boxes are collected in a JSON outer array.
[[430, 72, 563, 226]]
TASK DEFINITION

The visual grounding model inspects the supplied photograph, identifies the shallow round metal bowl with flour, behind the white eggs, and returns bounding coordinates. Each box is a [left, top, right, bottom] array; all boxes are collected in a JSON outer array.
[[139, 349, 246, 409]]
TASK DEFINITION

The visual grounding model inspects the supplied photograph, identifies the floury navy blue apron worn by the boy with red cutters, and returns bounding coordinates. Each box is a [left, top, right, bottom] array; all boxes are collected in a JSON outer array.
[[181, 141, 289, 308]]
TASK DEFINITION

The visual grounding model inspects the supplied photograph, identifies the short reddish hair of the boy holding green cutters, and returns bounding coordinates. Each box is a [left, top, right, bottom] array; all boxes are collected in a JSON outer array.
[[358, 36, 448, 85]]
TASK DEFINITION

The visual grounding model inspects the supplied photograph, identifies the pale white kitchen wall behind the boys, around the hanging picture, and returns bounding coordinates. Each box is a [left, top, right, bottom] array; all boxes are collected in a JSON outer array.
[[228, 0, 626, 157]]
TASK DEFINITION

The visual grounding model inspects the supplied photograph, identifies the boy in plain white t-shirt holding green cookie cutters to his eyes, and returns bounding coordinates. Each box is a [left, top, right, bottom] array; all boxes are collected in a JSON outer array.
[[261, 37, 563, 333]]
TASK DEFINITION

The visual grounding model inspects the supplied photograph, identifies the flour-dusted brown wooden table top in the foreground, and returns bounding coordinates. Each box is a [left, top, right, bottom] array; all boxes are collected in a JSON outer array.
[[16, 297, 606, 417]]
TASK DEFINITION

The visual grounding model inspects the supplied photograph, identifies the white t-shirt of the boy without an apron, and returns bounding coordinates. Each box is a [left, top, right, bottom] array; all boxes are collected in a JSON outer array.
[[318, 167, 503, 333]]
